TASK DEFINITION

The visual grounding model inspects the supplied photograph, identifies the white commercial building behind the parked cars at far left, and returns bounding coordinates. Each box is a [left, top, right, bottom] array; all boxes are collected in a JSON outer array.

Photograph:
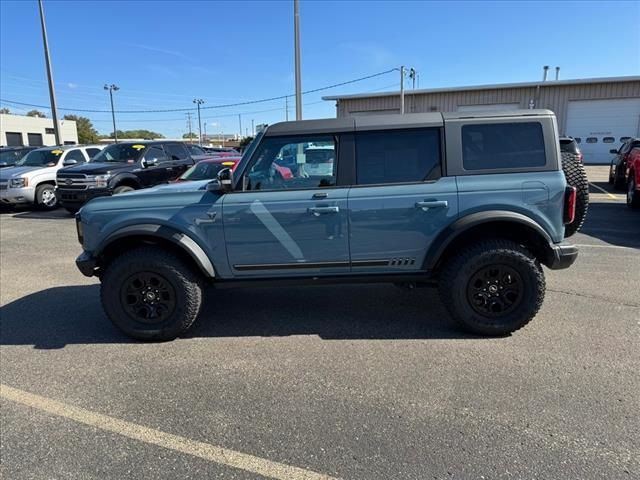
[[0, 113, 78, 147]]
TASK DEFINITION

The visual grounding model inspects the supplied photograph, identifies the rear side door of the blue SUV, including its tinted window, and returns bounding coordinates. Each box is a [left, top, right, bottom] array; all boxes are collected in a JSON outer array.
[[348, 126, 458, 273]]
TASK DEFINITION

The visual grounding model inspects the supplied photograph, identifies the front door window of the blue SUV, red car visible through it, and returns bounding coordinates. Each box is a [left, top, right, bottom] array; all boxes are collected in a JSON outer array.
[[243, 135, 338, 190]]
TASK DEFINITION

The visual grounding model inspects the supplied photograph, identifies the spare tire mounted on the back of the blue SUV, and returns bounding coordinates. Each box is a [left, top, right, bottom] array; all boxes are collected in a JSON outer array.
[[560, 137, 589, 237]]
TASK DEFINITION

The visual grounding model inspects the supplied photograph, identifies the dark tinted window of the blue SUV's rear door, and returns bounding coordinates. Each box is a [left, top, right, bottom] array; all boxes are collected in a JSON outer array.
[[356, 128, 441, 185]]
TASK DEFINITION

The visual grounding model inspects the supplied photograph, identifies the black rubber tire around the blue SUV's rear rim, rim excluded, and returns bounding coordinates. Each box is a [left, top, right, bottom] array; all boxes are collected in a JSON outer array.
[[439, 239, 545, 336]]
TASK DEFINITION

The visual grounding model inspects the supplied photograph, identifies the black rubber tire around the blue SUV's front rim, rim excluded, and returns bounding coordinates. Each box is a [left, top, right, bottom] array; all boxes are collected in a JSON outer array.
[[100, 247, 203, 341]]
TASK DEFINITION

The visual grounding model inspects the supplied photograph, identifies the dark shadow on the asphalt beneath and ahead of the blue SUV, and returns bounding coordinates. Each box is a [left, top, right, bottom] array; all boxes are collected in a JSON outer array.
[[0, 285, 480, 349]]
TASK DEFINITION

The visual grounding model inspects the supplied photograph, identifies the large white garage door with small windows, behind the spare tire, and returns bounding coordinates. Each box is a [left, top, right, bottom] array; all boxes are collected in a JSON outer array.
[[566, 98, 640, 163]]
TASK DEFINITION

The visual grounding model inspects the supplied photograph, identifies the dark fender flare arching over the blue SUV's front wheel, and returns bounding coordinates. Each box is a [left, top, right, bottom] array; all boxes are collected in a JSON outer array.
[[94, 223, 216, 278]]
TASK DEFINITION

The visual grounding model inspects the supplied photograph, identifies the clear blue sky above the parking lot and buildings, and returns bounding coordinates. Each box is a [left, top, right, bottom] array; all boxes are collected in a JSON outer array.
[[0, 0, 640, 137]]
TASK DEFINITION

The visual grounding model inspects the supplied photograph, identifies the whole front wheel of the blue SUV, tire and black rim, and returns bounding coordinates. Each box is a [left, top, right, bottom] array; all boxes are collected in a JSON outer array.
[[100, 247, 202, 341]]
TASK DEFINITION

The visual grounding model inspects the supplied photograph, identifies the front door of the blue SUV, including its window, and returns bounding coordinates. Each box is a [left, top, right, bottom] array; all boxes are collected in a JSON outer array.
[[223, 135, 349, 277]]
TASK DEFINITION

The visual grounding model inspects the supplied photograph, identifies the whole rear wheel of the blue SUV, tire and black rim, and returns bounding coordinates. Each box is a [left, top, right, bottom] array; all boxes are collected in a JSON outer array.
[[440, 239, 545, 336]]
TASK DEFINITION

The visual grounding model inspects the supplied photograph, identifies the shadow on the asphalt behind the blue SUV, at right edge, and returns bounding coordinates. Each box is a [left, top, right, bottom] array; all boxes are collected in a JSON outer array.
[[571, 202, 640, 249]]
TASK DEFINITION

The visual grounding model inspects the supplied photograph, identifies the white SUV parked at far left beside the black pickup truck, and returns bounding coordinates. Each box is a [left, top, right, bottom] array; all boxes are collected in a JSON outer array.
[[0, 145, 104, 209]]
